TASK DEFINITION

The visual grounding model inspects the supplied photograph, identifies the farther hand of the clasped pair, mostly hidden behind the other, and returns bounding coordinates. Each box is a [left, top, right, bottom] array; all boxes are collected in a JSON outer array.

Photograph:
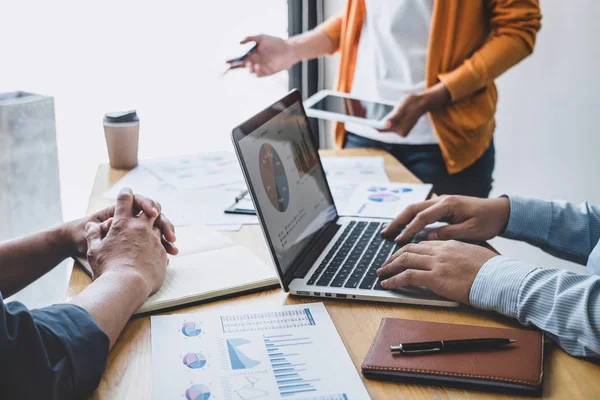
[[65, 194, 179, 257]]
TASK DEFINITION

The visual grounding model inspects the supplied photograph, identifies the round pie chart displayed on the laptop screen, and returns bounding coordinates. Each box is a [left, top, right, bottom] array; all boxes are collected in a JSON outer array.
[[258, 143, 290, 212]]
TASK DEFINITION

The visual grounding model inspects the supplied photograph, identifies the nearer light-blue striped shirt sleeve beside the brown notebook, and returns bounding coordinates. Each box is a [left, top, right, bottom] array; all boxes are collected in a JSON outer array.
[[469, 256, 600, 358]]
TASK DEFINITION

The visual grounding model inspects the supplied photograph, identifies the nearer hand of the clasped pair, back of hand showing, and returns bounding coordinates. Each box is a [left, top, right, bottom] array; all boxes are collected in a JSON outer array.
[[85, 188, 168, 296]]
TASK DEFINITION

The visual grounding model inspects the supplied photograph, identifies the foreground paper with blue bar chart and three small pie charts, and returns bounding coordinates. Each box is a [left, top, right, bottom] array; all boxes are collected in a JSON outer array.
[[152, 303, 370, 400]]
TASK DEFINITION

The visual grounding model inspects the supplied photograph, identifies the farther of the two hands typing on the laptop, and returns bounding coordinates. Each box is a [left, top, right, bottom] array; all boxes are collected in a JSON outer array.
[[381, 196, 510, 242]]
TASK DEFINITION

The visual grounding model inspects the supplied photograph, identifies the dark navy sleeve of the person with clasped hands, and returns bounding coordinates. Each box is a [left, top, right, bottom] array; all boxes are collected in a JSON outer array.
[[0, 295, 110, 399]]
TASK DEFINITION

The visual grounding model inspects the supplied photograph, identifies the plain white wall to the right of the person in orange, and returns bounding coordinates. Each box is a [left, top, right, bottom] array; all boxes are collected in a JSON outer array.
[[326, 0, 600, 271]]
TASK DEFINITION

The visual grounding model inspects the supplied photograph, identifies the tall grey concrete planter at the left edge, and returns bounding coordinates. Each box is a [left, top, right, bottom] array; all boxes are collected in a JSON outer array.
[[0, 92, 62, 240]]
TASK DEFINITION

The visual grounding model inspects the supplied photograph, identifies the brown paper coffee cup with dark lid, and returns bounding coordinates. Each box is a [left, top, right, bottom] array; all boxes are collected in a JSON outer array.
[[104, 110, 140, 169]]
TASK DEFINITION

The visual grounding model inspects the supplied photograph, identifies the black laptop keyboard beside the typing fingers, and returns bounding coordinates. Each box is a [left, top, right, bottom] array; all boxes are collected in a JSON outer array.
[[307, 221, 400, 290]]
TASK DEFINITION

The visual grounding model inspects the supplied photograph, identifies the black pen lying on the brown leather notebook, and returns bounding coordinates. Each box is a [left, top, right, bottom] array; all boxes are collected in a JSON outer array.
[[390, 338, 516, 355]]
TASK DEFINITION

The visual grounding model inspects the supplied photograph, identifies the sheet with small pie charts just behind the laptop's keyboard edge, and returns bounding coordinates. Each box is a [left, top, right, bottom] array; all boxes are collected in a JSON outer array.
[[331, 181, 433, 218]]
